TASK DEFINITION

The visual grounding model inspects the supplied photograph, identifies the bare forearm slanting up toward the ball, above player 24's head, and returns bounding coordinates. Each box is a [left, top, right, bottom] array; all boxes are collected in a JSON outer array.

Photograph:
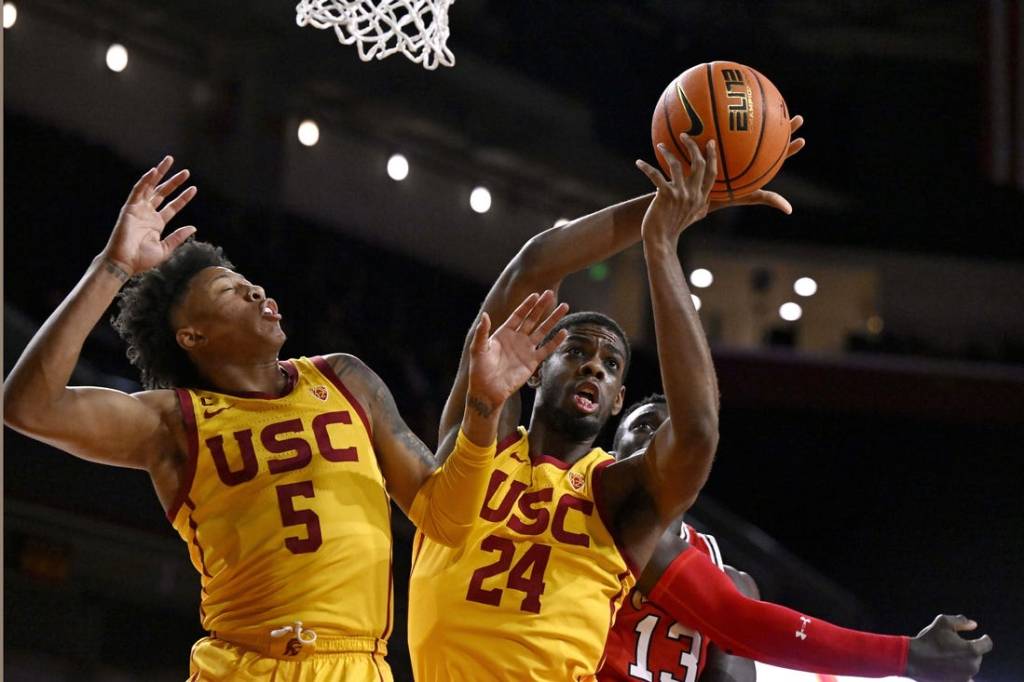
[[516, 194, 653, 291]]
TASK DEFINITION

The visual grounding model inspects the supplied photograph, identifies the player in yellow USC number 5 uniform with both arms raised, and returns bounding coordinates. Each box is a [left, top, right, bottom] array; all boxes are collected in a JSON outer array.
[[4, 157, 564, 681]]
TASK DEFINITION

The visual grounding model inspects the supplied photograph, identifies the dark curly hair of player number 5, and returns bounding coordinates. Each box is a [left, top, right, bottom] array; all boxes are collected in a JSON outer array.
[[111, 240, 234, 389]]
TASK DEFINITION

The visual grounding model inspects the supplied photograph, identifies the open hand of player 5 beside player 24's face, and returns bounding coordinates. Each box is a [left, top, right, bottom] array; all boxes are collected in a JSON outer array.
[[467, 291, 569, 417]]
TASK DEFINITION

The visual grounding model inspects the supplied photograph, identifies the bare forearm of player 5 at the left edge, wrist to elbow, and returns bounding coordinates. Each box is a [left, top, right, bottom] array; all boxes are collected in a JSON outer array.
[[4, 255, 128, 432]]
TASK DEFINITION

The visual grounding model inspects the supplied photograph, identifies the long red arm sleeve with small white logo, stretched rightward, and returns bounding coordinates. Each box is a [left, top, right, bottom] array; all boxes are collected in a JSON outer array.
[[641, 547, 909, 677]]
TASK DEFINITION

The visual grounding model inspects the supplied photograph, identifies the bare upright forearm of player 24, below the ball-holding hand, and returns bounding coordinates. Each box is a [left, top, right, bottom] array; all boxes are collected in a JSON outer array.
[[644, 239, 718, 499]]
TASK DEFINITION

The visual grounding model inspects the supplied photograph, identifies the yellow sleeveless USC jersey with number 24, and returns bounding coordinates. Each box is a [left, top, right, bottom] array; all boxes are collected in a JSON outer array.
[[409, 428, 635, 682]]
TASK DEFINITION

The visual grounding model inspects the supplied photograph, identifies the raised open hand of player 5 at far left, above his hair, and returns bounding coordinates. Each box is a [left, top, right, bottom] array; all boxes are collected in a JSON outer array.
[[102, 157, 197, 276]]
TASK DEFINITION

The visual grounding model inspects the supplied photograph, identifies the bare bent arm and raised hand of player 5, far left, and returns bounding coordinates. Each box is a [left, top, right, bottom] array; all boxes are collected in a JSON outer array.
[[4, 157, 196, 470]]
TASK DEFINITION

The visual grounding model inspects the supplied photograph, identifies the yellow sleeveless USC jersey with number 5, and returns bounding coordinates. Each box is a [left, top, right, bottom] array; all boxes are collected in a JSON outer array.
[[167, 357, 391, 640]]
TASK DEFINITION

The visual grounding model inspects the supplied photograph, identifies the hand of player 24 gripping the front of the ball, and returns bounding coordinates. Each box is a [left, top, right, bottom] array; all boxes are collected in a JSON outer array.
[[637, 133, 718, 242]]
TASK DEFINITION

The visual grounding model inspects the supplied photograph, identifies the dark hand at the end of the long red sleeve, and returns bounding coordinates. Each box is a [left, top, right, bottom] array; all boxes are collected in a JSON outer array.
[[906, 615, 992, 682]]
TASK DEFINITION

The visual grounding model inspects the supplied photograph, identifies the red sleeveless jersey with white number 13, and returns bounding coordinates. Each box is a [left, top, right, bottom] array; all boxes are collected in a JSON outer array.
[[597, 523, 724, 682]]
